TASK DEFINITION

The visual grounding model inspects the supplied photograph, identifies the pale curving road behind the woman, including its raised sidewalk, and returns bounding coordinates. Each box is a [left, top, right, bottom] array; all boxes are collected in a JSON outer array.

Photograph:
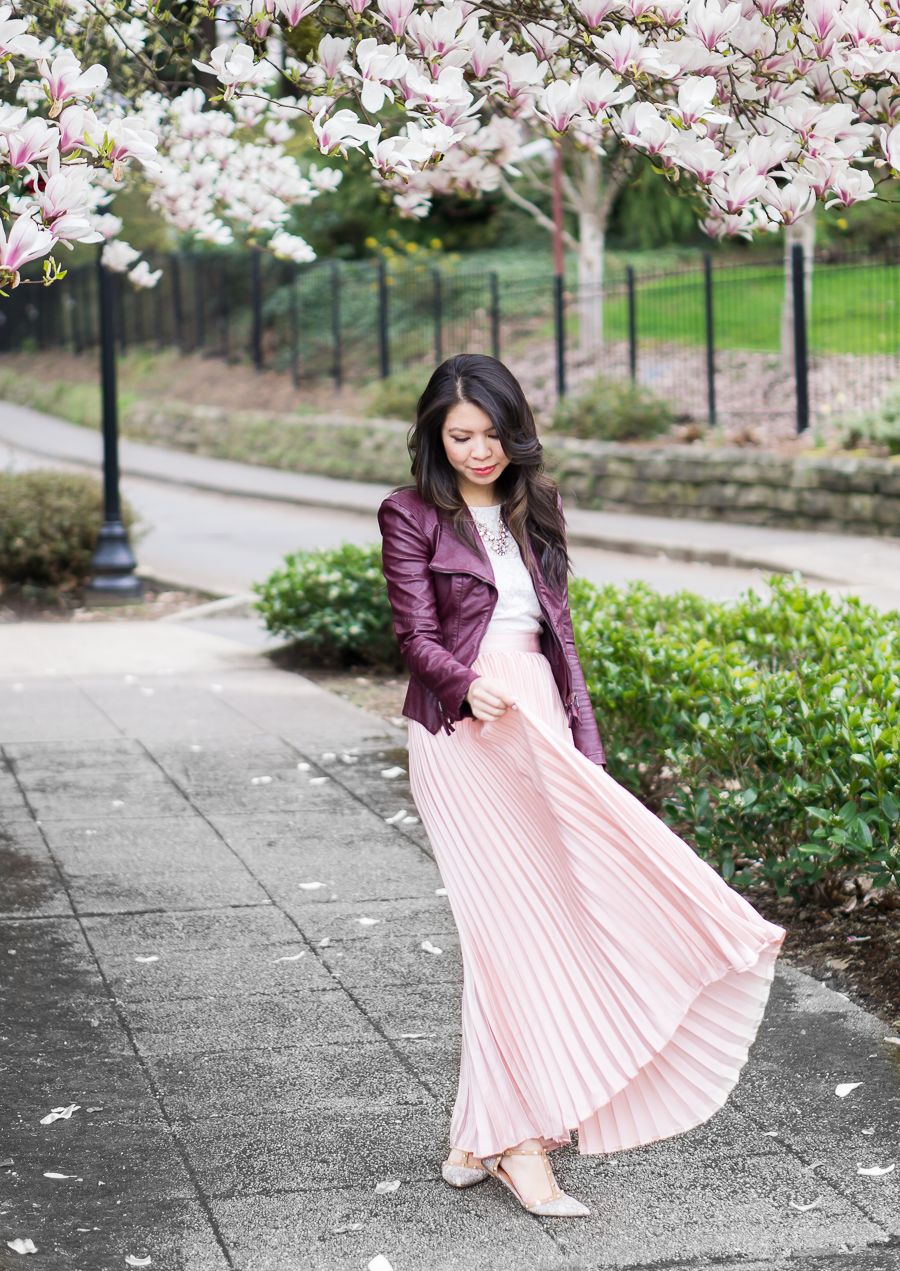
[[0, 403, 900, 609]]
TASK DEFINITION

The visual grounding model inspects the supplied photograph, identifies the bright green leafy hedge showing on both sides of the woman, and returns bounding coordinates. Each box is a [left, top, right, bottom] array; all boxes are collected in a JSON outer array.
[[256, 545, 900, 902]]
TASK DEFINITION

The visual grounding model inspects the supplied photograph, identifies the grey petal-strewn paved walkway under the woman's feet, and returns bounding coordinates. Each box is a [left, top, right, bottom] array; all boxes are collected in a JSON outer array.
[[0, 623, 900, 1271]]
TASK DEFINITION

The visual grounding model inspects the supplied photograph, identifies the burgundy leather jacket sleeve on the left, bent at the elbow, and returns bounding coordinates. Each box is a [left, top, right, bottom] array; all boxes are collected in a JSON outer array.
[[378, 497, 478, 731]]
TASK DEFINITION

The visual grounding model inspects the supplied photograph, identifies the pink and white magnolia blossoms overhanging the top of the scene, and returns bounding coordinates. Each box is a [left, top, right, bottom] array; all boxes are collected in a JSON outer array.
[[0, 0, 900, 296]]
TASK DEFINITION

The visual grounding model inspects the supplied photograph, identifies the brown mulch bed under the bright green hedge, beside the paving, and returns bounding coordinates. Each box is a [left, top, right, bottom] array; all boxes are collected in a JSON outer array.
[[298, 649, 900, 1033]]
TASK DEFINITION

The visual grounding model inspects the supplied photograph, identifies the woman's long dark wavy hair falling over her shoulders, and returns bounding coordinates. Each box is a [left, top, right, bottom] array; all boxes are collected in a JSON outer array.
[[396, 353, 572, 594]]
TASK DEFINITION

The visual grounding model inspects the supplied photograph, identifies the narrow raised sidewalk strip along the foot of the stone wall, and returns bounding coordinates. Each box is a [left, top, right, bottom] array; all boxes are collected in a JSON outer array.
[[7, 403, 900, 609]]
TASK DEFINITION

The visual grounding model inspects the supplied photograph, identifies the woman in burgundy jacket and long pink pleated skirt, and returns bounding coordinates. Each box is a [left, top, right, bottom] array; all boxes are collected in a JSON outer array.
[[379, 353, 786, 1216]]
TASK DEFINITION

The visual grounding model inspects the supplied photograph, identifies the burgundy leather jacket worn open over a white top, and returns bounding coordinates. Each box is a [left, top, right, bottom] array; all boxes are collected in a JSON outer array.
[[378, 486, 606, 764]]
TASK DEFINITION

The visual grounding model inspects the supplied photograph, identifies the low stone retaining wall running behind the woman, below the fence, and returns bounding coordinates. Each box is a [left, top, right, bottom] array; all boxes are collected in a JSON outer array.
[[126, 405, 900, 536]]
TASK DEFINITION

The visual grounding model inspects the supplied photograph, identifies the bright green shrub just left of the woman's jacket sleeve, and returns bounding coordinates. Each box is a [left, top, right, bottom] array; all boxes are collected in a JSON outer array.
[[253, 543, 400, 669]]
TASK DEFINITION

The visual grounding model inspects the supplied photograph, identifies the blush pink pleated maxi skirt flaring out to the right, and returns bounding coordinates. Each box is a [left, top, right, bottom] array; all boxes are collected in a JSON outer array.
[[408, 632, 787, 1157]]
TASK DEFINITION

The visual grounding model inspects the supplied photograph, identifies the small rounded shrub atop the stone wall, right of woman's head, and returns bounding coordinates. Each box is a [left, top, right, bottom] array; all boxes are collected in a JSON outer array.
[[553, 375, 678, 441]]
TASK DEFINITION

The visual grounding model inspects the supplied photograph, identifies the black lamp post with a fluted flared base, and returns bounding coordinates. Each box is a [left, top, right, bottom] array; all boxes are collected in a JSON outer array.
[[85, 254, 144, 605]]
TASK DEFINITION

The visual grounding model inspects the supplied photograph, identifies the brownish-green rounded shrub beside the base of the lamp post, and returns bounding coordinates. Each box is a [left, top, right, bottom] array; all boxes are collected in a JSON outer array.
[[0, 469, 135, 588]]
